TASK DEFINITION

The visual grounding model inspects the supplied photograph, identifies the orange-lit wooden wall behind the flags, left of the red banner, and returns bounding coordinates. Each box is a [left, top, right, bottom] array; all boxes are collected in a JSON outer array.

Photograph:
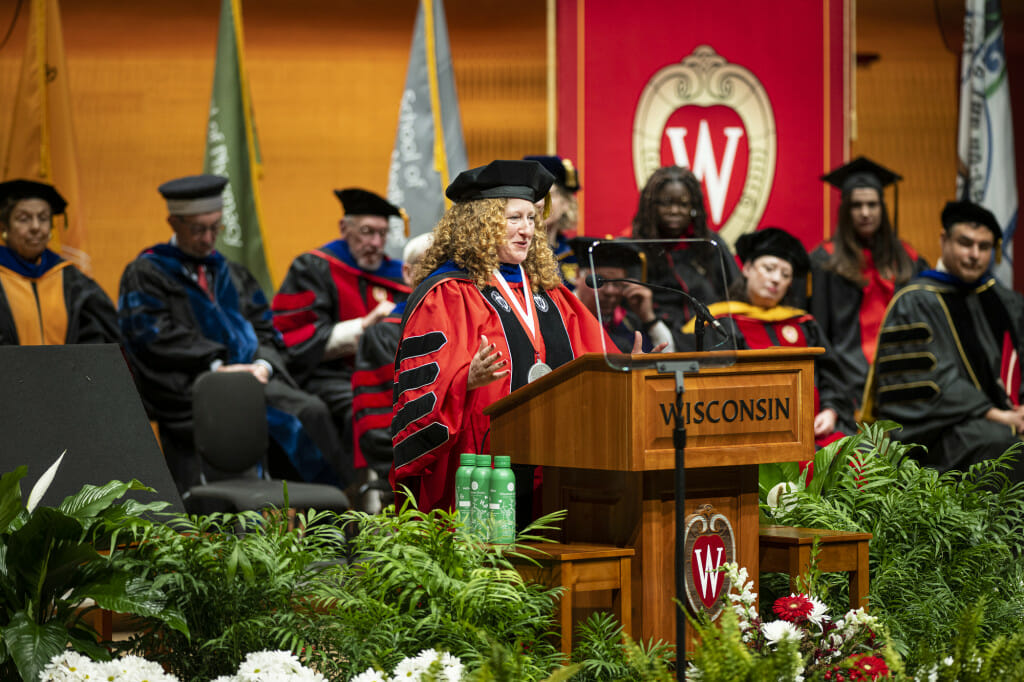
[[0, 0, 546, 296]]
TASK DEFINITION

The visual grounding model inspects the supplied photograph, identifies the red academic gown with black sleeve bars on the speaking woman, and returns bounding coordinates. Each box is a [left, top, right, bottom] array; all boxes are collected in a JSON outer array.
[[389, 265, 614, 511]]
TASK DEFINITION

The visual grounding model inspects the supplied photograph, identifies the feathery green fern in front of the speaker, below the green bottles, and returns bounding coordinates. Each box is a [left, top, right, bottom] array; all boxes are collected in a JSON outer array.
[[296, 493, 564, 680]]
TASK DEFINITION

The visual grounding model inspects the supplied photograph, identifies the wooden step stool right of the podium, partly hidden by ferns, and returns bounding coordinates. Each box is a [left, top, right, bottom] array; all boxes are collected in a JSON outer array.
[[758, 525, 871, 611]]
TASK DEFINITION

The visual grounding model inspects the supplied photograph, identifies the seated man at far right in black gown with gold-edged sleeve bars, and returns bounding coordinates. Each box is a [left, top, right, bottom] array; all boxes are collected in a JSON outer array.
[[864, 201, 1024, 481]]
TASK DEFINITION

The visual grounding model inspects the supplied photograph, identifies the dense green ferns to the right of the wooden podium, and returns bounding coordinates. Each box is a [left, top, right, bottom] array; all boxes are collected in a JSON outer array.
[[761, 422, 1024, 665]]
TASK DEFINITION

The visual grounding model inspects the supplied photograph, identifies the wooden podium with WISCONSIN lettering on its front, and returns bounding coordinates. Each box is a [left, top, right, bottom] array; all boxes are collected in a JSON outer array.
[[485, 348, 822, 643]]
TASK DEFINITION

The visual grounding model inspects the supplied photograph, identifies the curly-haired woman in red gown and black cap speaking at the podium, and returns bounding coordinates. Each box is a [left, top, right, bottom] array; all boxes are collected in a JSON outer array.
[[390, 161, 614, 511]]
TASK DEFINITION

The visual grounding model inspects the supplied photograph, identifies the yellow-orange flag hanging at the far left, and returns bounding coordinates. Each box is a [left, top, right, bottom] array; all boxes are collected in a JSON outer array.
[[3, 0, 91, 272]]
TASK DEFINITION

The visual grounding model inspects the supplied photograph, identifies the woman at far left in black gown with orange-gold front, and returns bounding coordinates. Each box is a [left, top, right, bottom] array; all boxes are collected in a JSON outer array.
[[0, 180, 120, 346]]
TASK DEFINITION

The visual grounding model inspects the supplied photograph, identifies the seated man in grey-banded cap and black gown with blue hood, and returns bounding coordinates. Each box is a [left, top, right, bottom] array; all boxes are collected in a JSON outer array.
[[119, 175, 348, 492]]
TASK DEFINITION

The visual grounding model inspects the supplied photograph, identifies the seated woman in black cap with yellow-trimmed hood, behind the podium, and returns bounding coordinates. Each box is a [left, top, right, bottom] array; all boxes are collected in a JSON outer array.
[[684, 227, 856, 447]]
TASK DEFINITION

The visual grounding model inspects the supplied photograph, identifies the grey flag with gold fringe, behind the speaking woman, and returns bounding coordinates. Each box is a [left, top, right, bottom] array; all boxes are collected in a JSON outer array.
[[387, 0, 468, 255]]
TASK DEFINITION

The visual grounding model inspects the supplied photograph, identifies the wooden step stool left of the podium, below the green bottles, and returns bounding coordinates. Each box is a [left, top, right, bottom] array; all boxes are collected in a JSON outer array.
[[509, 543, 636, 655]]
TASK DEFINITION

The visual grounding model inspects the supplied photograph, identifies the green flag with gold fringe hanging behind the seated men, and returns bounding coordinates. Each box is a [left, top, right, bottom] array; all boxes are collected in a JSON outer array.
[[203, 0, 273, 298]]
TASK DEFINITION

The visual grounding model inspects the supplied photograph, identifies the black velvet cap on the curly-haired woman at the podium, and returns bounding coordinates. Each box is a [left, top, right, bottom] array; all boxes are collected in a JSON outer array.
[[444, 160, 555, 204]]
